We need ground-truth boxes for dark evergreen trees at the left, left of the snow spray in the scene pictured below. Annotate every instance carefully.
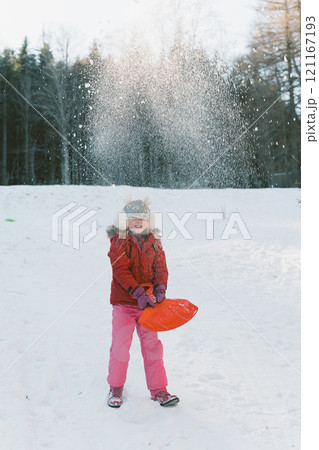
[0,38,96,185]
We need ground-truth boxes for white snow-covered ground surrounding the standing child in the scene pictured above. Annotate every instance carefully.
[0,186,300,450]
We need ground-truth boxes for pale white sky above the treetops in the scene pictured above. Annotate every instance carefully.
[0,0,258,59]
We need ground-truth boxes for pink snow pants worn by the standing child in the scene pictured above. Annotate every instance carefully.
[107,305,167,395]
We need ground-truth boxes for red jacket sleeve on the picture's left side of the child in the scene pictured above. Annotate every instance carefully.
[108,236,139,294]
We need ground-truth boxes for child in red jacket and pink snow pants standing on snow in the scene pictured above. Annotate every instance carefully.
[107,200,179,408]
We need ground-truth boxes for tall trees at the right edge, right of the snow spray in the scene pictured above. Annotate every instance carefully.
[233,0,301,187]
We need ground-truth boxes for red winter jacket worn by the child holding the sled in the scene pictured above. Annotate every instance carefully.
[108,231,168,305]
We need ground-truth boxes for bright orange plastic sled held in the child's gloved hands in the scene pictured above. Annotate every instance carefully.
[138,284,198,331]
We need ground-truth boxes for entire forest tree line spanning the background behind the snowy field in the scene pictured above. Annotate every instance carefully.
[0,0,300,187]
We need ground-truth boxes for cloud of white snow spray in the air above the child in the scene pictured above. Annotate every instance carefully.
[89,28,251,188]
